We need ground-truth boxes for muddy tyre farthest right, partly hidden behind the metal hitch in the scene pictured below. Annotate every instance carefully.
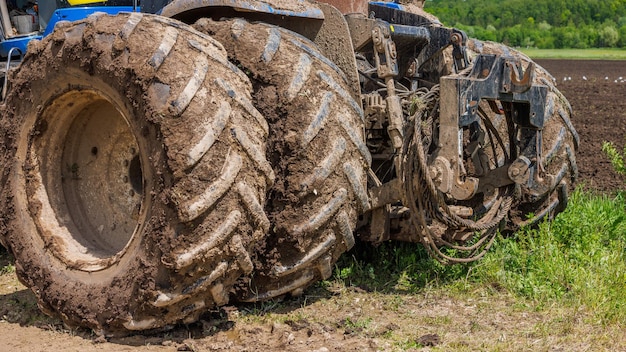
[468,40,579,230]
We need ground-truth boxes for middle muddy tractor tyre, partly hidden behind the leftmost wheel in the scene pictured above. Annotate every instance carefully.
[195,19,371,301]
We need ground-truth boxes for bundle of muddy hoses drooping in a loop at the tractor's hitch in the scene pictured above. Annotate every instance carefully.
[399,85,513,263]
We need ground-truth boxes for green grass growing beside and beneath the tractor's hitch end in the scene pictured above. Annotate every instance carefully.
[335,190,626,325]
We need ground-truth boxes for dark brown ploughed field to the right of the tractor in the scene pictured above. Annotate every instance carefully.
[537,60,626,193]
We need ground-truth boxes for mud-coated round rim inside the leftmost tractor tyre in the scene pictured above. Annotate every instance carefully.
[31,90,149,271]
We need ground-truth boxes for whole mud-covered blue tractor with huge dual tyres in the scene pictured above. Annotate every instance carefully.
[0,0,579,336]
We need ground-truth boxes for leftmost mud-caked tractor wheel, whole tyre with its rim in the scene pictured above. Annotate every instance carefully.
[0,13,274,335]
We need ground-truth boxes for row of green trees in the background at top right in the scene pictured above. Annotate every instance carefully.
[425,0,626,49]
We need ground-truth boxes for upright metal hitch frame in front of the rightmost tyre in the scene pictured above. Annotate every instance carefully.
[432,55,548,200]
